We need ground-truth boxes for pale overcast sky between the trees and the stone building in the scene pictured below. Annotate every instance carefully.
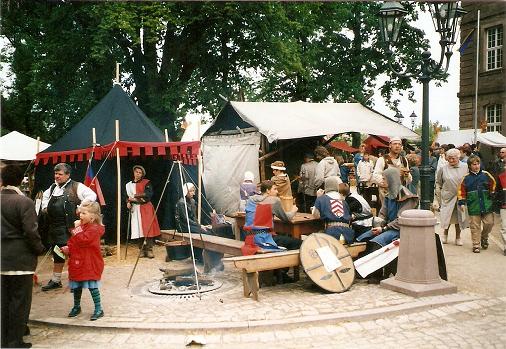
[373,12,460,130]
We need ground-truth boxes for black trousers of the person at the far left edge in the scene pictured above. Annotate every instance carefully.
[1,274,33,348]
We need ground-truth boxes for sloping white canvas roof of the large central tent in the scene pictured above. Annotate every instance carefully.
[206,101,418,142]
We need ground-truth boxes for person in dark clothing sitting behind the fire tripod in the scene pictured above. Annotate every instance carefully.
[175,183,224,272]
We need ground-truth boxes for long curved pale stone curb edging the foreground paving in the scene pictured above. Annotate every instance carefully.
[29,294,481,331]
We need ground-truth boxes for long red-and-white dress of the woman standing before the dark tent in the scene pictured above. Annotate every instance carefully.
[126,178,160,239]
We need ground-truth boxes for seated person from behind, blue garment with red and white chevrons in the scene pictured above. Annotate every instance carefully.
[313,176,355,244]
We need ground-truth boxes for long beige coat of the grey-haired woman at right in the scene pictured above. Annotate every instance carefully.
[436,161,469,230]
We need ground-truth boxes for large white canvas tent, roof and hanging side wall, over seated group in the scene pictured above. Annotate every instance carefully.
[202,102,418,214]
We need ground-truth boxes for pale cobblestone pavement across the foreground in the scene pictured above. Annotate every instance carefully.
[25,212,506,348]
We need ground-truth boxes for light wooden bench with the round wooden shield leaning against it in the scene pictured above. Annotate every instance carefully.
[223,242,366,301]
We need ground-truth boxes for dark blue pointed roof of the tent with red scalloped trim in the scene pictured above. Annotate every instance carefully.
[44,85,165,153]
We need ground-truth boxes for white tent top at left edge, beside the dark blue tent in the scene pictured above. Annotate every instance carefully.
[0,131,51,161]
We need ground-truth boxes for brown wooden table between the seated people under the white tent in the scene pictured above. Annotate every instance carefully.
[230,212,325,239]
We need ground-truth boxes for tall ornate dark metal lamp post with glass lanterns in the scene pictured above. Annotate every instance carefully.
[379,1,466,210]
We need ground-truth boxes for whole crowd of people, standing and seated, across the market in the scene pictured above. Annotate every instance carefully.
[0,137,506,347]
